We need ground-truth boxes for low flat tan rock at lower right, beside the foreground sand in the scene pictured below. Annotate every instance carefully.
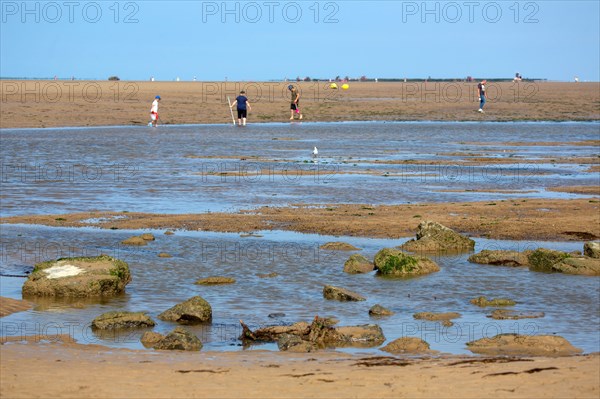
[467,334,581,356]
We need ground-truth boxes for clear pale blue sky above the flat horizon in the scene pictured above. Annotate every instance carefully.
[0,0,600,81]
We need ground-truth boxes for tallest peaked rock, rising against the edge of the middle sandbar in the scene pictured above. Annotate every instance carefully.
[401,220,475,252]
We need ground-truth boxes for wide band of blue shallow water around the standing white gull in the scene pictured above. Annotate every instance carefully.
[0,122,600,216]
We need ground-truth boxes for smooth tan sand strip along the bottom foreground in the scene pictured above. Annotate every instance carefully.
[0,337,600,398]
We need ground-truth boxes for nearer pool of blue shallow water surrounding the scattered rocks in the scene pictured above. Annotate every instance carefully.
[0,225,600,353]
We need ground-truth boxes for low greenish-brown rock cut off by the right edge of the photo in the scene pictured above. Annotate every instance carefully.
[528,248,600,276]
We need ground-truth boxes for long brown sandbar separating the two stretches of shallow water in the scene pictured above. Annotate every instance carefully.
[0,199,600,241]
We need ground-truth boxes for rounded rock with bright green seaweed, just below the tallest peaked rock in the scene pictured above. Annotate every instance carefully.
[374,248,440,277]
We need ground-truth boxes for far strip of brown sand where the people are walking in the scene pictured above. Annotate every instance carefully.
[0,80,600,128]
